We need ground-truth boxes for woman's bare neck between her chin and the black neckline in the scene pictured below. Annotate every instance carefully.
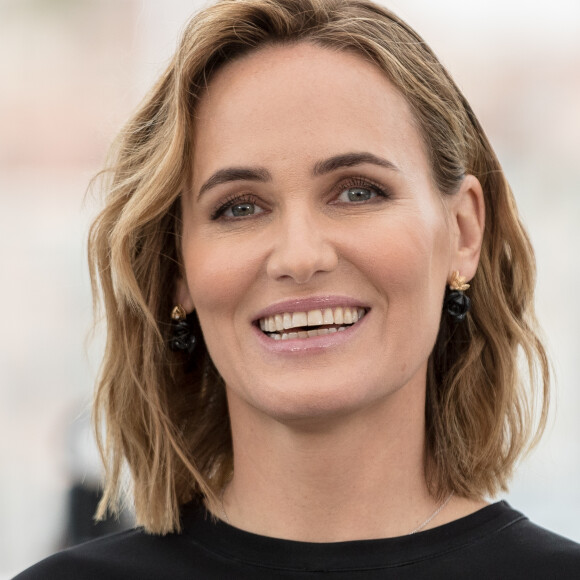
[217,372,450,542]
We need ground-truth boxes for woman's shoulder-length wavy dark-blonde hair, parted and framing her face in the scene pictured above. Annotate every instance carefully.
[89,0,549,534]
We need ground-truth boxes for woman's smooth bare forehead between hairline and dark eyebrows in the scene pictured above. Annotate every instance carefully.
[193,42,425,176]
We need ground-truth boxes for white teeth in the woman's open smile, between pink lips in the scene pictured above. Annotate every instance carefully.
[258,306,367,340]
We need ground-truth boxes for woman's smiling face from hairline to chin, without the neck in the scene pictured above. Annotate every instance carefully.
[178,43,457,420]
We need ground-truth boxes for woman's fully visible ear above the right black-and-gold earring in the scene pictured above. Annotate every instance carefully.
[450,175,485,280]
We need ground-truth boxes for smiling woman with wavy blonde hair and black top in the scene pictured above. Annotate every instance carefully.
[19,0,580,579]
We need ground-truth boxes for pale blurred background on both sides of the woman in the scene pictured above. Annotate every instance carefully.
[0,0,580,580]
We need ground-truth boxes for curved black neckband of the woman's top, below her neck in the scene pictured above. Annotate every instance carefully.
[182,501,526,572]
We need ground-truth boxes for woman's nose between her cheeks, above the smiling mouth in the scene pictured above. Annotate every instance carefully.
[267,211,338,284]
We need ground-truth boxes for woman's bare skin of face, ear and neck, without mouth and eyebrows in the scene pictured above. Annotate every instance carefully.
[176,43,484,541]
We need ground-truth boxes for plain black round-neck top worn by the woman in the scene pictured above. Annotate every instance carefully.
[16,502,580,580]
